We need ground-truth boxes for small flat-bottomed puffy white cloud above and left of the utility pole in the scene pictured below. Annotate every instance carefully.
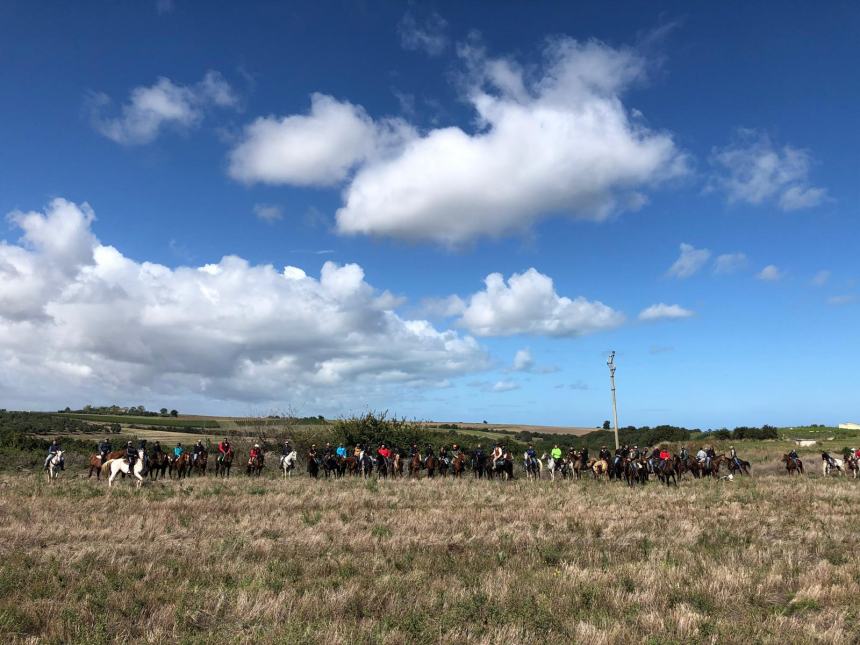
[458,268,624,336]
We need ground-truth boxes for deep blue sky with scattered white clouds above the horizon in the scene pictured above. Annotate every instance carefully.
[0,0,860,427]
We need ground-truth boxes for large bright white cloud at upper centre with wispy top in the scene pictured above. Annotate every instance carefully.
[230,38,687,245]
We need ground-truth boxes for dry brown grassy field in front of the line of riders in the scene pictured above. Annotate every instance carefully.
[0,442,860,643]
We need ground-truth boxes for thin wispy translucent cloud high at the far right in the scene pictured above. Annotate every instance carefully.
[710,130,828,211]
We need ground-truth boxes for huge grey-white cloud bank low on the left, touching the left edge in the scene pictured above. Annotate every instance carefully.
[0,199,488,405]
